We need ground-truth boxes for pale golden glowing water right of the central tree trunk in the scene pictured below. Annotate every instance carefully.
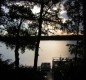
[38,41,75,64]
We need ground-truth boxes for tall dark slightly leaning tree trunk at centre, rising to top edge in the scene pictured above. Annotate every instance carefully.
[34,0,44,71]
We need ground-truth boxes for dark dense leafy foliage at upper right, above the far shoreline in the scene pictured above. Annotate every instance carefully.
[63,0,83,34]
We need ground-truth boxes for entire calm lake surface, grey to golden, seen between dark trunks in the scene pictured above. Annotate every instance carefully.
[0,41,76,66]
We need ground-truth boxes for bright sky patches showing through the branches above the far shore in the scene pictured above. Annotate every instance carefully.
[0,0,83,36]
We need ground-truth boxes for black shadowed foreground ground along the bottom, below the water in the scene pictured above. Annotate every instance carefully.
[0,64,86,80]
